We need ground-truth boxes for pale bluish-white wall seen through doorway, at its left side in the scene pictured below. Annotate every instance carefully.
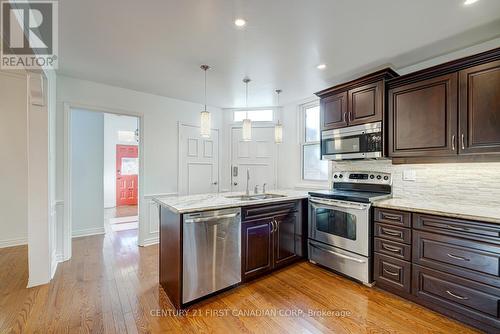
[70,109,104,236]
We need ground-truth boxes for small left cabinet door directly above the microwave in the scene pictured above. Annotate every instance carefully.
[320,92,347,130]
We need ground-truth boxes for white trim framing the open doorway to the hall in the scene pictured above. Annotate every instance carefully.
[62,102,147,261]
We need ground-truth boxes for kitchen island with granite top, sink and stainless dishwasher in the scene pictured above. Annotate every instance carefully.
[154,190,308,308]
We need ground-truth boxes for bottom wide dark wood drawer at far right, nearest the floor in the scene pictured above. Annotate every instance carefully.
[412,264,500,327]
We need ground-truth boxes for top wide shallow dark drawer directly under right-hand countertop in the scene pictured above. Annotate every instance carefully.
[413,213,500,243]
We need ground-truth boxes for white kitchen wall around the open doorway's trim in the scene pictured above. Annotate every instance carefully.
[57,76,224,244]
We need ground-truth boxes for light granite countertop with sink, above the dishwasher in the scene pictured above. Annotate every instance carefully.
[153,189,308,213]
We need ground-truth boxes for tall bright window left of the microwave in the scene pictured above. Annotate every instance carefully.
[301,102,328,181]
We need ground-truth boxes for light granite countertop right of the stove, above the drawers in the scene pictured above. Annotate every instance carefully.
[373,197,500,224]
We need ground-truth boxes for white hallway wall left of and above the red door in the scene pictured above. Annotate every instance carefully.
[104,113,139,208]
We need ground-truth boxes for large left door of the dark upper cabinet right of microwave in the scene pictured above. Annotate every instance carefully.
[388,73,458,157]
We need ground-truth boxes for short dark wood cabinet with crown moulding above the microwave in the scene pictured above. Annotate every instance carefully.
[316,68,398,130]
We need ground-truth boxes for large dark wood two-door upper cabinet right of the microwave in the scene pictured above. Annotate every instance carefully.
[387,48,500,163]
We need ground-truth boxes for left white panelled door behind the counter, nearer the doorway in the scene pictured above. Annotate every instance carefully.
[179,125,219,195]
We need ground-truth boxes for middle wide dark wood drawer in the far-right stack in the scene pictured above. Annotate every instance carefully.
[413,231,500,286]
